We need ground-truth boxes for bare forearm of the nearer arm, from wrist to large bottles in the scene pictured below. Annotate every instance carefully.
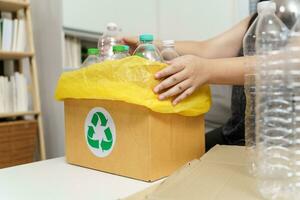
[206,57,250,85]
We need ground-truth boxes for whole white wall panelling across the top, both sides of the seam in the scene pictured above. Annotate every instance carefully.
[63,0,248,40]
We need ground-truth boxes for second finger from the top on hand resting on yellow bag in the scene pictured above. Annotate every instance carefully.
[154,70,187,93]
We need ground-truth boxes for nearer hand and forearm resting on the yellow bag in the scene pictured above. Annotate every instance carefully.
[154,55,248,105]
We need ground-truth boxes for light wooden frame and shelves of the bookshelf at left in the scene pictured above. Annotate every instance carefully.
[0,0,46,160]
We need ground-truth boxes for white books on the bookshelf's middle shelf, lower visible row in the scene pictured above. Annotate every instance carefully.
[0,72,28,113]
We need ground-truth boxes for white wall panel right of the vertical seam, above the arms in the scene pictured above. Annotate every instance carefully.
[159,0,234,40]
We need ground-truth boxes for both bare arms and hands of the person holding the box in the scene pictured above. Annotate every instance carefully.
[123,17,250,105]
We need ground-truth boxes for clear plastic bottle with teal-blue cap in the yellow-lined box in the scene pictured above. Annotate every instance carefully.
[133,34,162,62]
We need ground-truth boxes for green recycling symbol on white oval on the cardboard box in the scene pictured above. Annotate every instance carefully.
[84,107,116,158]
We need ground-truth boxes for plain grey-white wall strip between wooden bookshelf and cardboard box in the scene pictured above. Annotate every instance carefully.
[31,0,64,158]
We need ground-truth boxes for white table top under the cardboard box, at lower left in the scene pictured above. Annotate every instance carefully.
[0,157,162,200]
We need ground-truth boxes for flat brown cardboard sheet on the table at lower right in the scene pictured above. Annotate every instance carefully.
[126,146,262,200]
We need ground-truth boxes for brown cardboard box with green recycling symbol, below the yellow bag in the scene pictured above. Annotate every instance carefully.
[65,100,205,181]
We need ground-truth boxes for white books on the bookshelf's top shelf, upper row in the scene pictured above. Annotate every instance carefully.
[0,10,26,52]
